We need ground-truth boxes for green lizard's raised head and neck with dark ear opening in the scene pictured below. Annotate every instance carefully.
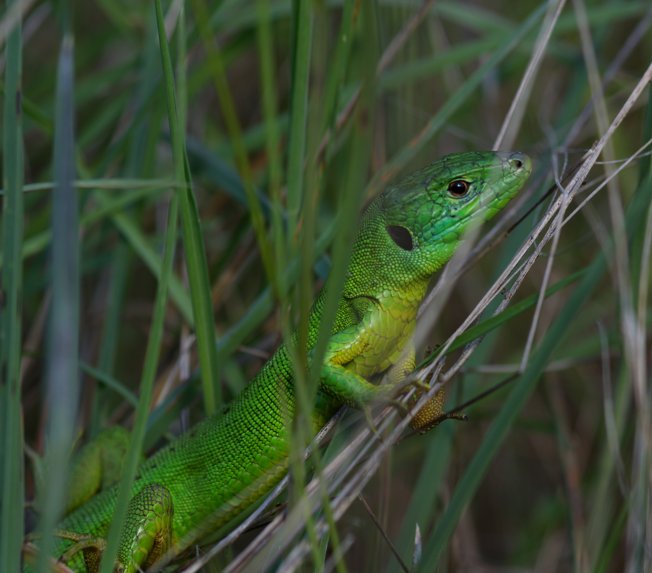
[345,152,532,298]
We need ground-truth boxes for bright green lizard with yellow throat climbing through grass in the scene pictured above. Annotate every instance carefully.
[27,152,531,572]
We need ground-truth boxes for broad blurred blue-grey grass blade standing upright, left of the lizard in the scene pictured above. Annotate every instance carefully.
[38,33,80,572]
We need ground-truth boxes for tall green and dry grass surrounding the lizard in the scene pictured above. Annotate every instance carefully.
[0,0,652,573]
